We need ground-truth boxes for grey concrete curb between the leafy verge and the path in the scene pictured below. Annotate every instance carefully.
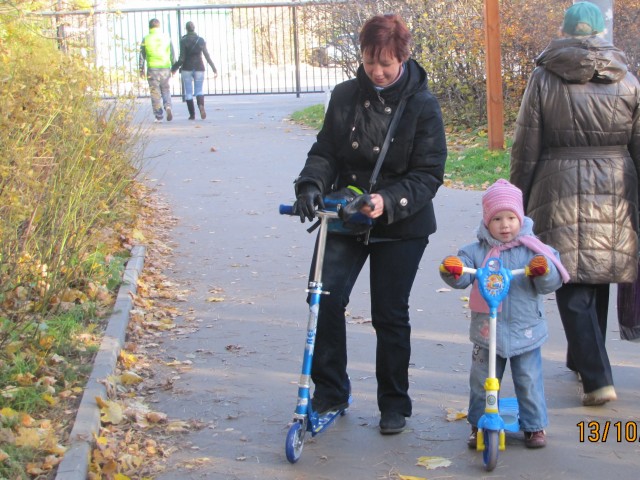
[56,246,146,480]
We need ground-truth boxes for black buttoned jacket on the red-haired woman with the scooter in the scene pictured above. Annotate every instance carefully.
[296,60,447,238]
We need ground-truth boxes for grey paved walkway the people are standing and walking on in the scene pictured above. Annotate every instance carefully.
[132,95,640,480]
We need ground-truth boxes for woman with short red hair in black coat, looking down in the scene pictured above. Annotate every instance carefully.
[295,15,447,434]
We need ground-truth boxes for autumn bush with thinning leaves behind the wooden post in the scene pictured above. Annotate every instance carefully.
[308,0,640,128]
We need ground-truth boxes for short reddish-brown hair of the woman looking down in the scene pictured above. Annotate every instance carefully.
[359,14,411,62]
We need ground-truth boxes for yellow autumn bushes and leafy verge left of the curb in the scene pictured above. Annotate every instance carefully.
[0,1,144,479]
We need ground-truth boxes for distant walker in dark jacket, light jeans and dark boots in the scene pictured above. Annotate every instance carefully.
[171,22,218,120]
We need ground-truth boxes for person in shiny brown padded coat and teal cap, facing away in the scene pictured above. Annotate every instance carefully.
[510,2,640,406]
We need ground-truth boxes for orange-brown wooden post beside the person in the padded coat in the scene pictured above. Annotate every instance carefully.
[484,0,504,150]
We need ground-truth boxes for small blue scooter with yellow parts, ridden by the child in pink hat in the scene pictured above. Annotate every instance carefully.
[462,257,525,471]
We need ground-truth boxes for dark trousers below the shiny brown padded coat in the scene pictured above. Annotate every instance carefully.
[556,283,613,393]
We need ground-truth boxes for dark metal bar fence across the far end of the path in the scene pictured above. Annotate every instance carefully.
[41,1,360,97]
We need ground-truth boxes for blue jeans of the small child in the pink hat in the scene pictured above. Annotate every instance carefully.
[467,345,548,432]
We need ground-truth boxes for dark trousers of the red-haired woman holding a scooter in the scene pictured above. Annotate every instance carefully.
[311,235,428,417]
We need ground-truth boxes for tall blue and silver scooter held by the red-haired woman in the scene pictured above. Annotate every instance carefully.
[280,199,370,463]
